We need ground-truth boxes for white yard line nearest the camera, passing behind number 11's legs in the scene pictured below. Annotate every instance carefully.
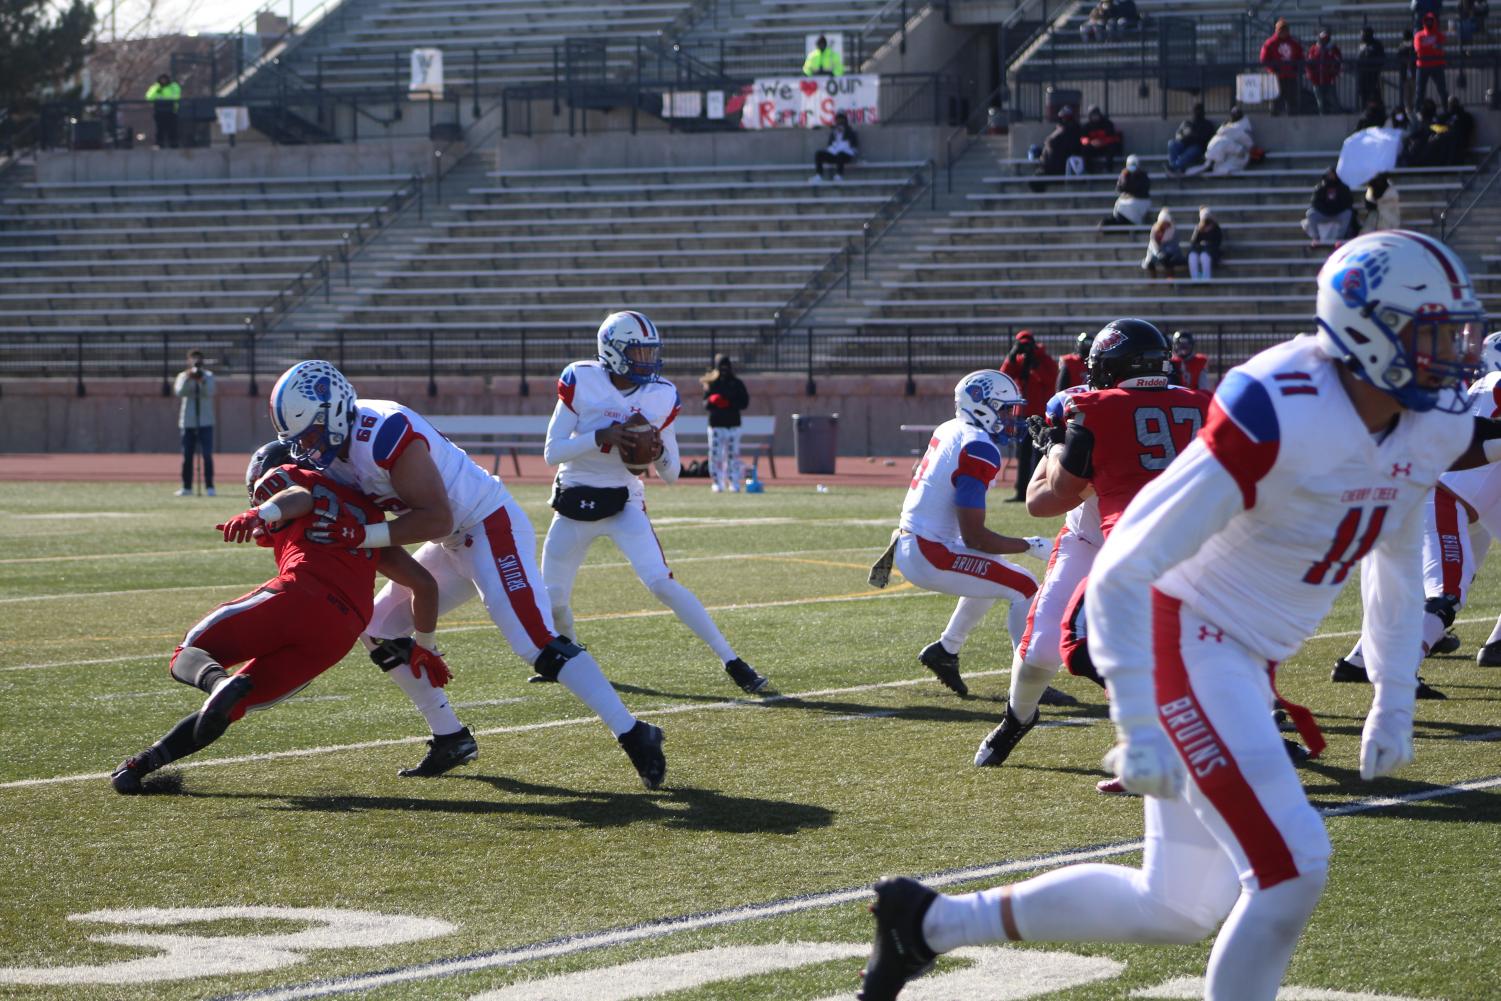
[216,776,1501,1001]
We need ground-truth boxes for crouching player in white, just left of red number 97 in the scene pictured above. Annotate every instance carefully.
[889,369,1049,695]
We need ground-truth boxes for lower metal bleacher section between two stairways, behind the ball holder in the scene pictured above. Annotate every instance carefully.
[311,162,923,368]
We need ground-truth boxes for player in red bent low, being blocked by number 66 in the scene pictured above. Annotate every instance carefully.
[110,441,449,794]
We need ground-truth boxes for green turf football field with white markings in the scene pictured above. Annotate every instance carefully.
[0,483,1501,1001]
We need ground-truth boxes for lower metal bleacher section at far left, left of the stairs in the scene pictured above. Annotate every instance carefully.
[0,174,414,374]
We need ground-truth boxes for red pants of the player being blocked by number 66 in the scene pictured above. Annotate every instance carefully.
[173,576,365,720]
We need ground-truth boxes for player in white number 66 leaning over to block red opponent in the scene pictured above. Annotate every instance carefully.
[270,362,666,789]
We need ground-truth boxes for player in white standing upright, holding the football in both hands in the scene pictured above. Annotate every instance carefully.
[542,311,767,695]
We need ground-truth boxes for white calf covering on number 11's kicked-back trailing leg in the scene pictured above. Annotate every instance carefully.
[1001,863,1224,948]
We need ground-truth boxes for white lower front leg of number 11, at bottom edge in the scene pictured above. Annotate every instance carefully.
[1205,869,1328,1001]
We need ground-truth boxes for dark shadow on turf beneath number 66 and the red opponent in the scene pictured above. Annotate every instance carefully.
[188,774,835,834]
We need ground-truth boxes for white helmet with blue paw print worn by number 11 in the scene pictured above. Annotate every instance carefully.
[1318,230,1486,413]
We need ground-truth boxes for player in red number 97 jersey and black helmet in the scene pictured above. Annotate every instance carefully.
[974,320,1210,767]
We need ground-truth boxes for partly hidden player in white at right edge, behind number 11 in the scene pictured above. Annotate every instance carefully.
[1331,333,1501,681]
